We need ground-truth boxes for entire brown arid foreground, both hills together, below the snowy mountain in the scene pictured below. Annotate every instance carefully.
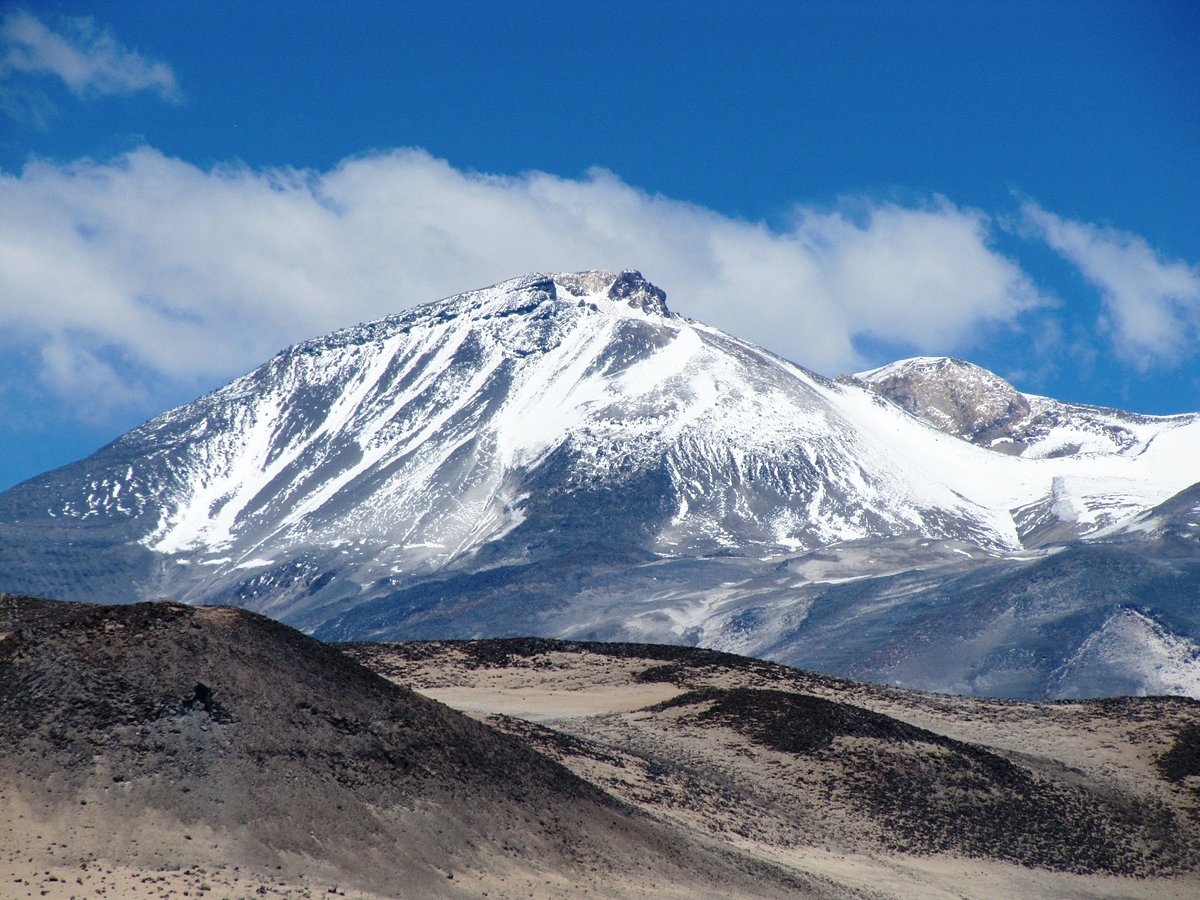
[0,595,1200,898]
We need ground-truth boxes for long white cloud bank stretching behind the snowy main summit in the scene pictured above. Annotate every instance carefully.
[0,148,1040,417]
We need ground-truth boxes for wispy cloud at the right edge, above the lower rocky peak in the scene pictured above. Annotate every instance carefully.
[1021,202,1200,371]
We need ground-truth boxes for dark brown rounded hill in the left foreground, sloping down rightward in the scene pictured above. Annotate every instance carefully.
[0,595,830,898]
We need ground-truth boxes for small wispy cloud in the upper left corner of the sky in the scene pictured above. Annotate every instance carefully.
[0,10,180,101]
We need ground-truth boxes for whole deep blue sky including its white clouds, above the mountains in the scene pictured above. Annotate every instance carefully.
[0,0,1200,487]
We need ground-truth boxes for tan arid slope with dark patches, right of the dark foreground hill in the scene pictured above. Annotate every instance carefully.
[347,638,1200,898]
